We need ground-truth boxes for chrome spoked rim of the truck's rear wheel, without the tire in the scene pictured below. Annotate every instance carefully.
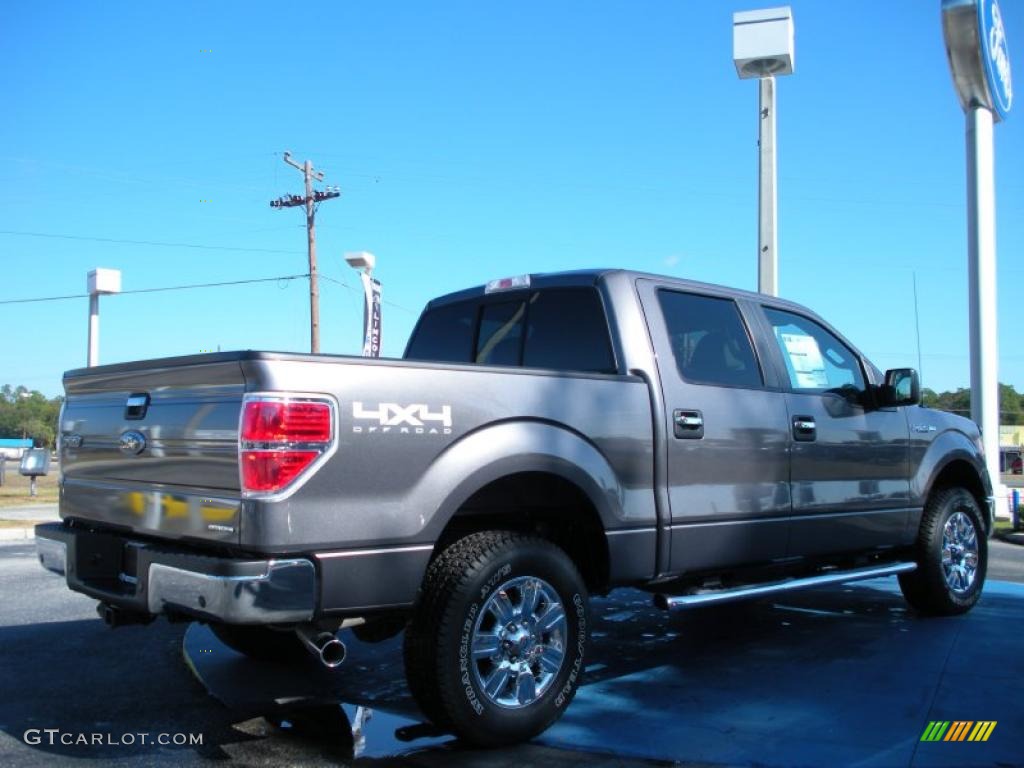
[471,577,566,709]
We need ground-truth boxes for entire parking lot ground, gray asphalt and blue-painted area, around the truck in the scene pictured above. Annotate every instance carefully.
[0,541,1024,766]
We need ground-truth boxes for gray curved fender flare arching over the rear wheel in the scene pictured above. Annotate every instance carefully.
[413,421,630,541]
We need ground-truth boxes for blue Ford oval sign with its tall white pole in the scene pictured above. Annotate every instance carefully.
[942,0,1014,512]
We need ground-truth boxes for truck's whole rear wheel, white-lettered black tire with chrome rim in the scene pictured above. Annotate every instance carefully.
[404,530,590,746]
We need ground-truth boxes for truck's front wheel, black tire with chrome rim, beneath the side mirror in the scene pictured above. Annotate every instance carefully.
[899,487,988,616]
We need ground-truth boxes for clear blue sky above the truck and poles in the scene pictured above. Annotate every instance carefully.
[0,0,1024,394]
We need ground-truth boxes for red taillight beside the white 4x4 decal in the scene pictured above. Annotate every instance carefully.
[239,395,334,496]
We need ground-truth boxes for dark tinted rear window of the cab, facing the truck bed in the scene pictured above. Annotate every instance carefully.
[406,288,615,374]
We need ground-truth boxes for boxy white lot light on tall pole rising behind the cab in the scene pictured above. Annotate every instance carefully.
[732,7,794,296]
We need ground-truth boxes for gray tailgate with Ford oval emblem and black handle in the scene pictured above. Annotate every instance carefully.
[60,353,245,543]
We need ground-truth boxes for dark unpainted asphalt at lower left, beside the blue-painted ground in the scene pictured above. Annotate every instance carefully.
[0,541,699,768]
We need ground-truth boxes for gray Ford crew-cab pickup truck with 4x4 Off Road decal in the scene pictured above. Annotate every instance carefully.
[36,269,992,744]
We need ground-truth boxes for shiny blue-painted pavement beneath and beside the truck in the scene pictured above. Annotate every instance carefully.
[183,580,1024,766]
